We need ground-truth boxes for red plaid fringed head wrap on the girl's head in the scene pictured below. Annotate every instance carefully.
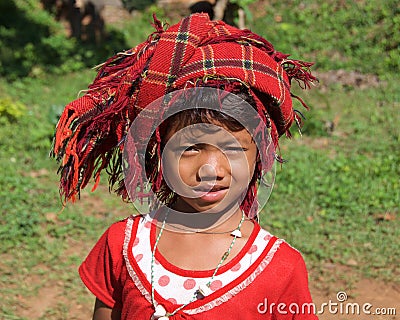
[52,14,316,210]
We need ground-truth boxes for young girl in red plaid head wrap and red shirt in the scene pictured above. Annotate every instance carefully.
[53,14,316,320]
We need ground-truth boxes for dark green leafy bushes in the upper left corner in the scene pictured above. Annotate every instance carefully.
[0,0,128,81]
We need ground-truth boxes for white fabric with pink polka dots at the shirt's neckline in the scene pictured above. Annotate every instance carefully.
[132,216,272,304]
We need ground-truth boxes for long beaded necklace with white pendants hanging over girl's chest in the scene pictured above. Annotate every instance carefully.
[151,211,245,320]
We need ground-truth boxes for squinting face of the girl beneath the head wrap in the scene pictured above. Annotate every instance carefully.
[162,123,257,212]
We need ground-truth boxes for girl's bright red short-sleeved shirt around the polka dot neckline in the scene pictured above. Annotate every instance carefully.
[79,216,317,320]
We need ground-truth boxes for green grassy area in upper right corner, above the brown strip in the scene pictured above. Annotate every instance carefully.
[253,0,400,76]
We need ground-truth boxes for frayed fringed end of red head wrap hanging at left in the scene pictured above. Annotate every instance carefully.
[50,16,164,201]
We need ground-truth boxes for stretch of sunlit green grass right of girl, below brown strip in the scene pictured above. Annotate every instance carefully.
[262,78,400,281]
